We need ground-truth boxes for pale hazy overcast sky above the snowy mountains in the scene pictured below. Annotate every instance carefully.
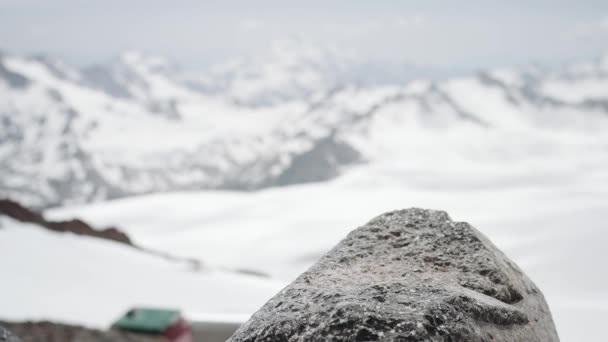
[0,0,608,69]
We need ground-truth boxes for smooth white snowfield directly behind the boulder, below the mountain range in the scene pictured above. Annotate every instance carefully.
[47,167,608,342]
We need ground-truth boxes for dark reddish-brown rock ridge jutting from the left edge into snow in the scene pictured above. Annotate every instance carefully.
[0,199,133,245]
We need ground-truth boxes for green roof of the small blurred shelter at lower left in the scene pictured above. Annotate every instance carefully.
[112,308,181,334]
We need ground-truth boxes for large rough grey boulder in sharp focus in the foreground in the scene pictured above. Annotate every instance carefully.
[228,209,559,342]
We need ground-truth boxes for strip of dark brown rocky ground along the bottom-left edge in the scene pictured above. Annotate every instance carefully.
[0,321,165,342]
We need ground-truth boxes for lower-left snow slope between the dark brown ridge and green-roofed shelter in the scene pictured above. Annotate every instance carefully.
[0,216,284,328]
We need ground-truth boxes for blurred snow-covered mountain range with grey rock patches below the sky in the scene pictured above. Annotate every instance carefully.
[0,42,608,206]
